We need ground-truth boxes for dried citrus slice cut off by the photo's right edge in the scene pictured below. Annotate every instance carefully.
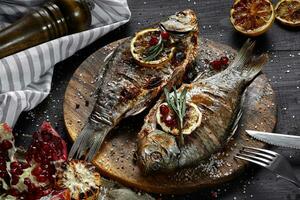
[275,0,300,27]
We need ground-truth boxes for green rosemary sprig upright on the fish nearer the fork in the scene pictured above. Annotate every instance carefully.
[164,87,187,146]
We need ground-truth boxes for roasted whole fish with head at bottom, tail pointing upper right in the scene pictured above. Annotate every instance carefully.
[138,41,268,174]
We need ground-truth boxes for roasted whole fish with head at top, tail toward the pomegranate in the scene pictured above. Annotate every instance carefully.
[69,10,199,160]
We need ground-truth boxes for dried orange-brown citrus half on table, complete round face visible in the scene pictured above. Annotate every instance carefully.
[230,0,275,37]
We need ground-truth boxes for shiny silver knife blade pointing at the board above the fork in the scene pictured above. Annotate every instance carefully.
[246,130,300,149]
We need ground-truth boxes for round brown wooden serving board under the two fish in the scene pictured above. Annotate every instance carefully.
[64,39,276,194]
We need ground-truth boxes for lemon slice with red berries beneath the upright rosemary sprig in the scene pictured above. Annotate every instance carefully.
[156,102,202,136]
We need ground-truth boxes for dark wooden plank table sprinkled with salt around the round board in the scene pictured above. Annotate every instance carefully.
[15,0,300,200]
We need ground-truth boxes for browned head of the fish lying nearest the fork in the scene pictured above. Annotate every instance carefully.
[138,129,180,174]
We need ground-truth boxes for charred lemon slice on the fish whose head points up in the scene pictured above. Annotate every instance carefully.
[130,28,175,67]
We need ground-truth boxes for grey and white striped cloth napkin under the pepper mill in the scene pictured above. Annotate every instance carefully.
[0,0,131,126]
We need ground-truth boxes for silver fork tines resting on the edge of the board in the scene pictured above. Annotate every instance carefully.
[235,146,278,167]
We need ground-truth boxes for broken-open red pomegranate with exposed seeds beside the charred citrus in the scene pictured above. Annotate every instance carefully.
[0,122,67,200]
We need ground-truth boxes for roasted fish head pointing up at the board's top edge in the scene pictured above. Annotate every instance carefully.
[160,9,198,33]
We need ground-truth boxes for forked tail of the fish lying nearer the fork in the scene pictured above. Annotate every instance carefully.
[228,39,268,82]
